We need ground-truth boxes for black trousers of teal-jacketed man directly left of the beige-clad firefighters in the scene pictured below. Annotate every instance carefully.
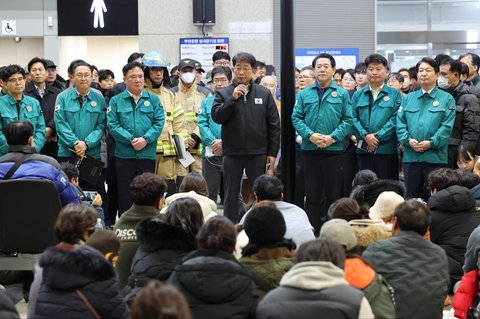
[115,157,155,217]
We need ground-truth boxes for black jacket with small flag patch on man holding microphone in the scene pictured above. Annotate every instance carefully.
[212,81,280,156]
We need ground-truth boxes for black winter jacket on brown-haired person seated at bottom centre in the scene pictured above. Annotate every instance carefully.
[169,249,258,319]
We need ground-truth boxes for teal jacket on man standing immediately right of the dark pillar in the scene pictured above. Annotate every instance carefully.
[292,81,352,152]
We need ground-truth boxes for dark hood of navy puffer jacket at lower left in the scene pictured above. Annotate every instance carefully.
[39,246,115,290]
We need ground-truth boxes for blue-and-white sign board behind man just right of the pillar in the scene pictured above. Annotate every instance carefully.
[295,48,358,69]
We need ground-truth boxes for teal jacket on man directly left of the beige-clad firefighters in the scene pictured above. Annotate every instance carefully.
[107,90,165,160]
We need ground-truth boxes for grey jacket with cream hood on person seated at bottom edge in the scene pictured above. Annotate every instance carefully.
[257,261,374,319]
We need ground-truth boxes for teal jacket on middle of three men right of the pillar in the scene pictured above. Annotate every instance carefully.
[352,84,402,154]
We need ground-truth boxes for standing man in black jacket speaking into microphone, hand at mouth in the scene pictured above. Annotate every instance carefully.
[212,52,280,223]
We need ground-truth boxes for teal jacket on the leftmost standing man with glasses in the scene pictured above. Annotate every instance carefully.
[0,94,47,156]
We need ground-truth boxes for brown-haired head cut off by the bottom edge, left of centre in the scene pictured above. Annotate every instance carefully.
[129,279,192,319]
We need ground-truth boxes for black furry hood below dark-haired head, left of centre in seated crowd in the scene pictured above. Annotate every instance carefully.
[136,218,195,252]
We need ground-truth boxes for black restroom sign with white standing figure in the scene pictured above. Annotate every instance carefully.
[57,0,138,36]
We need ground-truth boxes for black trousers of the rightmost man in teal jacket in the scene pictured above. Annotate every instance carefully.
[403,162,446,201]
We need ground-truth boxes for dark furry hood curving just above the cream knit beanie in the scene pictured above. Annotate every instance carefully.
[350,179,406,207]
